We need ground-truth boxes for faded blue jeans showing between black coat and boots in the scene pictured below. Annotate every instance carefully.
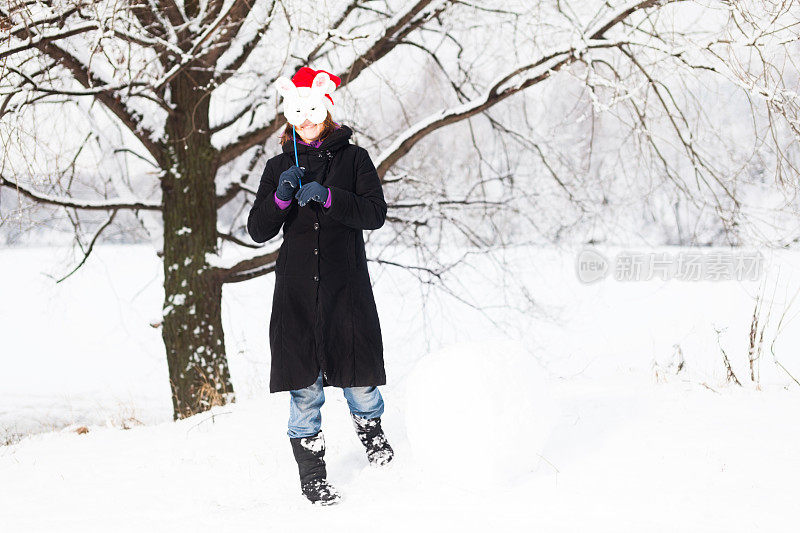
[287,371,383,438]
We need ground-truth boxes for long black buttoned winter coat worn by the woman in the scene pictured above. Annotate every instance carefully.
[247,125,386,392]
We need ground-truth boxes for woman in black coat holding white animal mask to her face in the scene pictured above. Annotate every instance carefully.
[247,67,393,505]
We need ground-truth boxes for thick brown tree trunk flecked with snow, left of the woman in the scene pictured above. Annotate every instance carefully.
[161,68,234,420]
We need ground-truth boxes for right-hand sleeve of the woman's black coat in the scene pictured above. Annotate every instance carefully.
[323,148,386,229]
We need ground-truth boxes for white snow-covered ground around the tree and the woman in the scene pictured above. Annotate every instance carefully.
[0,246,800,532]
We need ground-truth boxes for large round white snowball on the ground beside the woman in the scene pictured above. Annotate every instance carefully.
[406,339,557,488]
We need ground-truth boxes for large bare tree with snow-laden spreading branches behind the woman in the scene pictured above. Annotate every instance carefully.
[0,0,798,418]
